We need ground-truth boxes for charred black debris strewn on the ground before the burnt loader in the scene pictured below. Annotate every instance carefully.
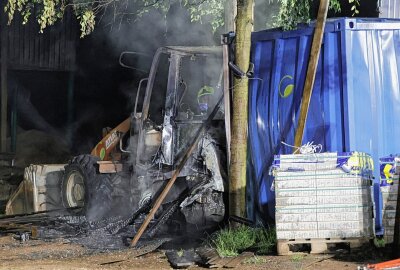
[0,211,170,251]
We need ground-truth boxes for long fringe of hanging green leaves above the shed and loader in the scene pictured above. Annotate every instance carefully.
[5,0,226,37]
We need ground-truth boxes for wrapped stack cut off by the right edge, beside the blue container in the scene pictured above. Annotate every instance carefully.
[379,155,400,244]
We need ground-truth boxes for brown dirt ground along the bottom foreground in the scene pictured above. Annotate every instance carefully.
[0,236,390,270]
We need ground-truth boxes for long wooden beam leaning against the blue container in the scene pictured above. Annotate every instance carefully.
[294,0,329,151]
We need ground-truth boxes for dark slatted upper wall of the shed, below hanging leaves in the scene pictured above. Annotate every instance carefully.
[7,12,78,71]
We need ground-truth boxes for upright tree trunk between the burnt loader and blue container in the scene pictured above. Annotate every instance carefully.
[228,0,254,217]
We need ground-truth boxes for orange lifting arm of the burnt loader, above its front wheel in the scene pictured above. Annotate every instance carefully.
[91,117,131,160]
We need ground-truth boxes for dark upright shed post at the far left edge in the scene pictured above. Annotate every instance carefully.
[0,8,8,152]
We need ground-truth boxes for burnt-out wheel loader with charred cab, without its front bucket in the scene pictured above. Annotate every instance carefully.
[60,47,230,234]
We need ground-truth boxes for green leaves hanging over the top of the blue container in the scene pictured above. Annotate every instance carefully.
[276,0,360,30]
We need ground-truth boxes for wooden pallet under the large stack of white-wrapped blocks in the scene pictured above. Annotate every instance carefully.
[277,238,370,255]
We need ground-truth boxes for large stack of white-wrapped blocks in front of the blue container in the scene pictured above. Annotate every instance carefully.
[271,152,374,240]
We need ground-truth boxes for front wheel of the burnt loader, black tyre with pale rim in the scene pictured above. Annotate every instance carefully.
[61,155,113,221]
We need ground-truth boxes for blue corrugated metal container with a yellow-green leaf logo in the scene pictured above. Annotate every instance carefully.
[248,18,400,234]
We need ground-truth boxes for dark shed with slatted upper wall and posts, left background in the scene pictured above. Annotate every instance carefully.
[0,7,79,152]
